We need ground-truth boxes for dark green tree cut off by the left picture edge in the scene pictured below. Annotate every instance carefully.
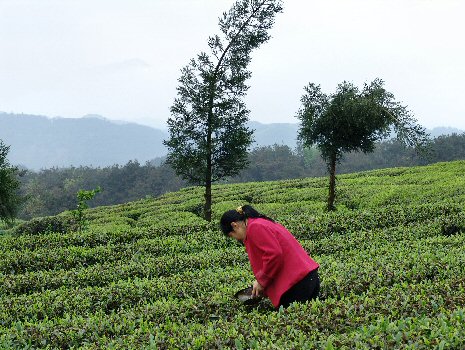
[0,140,22,224]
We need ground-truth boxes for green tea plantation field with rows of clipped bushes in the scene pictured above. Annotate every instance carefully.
[0,161,465,349]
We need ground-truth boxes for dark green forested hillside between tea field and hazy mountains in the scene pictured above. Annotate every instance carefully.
[16,134,465,219]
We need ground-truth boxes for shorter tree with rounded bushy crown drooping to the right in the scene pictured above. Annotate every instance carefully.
[297,79,429,210]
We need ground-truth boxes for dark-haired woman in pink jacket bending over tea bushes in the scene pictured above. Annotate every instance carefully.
[220,205,320,308]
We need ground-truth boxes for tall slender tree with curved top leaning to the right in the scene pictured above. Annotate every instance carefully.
[164,0,282,221]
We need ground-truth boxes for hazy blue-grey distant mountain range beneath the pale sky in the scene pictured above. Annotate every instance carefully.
[0,112,463,170]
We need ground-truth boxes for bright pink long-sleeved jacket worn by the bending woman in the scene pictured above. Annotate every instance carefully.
[244,218,319,307]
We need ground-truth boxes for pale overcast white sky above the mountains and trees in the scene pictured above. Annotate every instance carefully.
[0,0,465,129]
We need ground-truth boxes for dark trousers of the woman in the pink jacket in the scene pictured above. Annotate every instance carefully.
[279,269,320,308]
